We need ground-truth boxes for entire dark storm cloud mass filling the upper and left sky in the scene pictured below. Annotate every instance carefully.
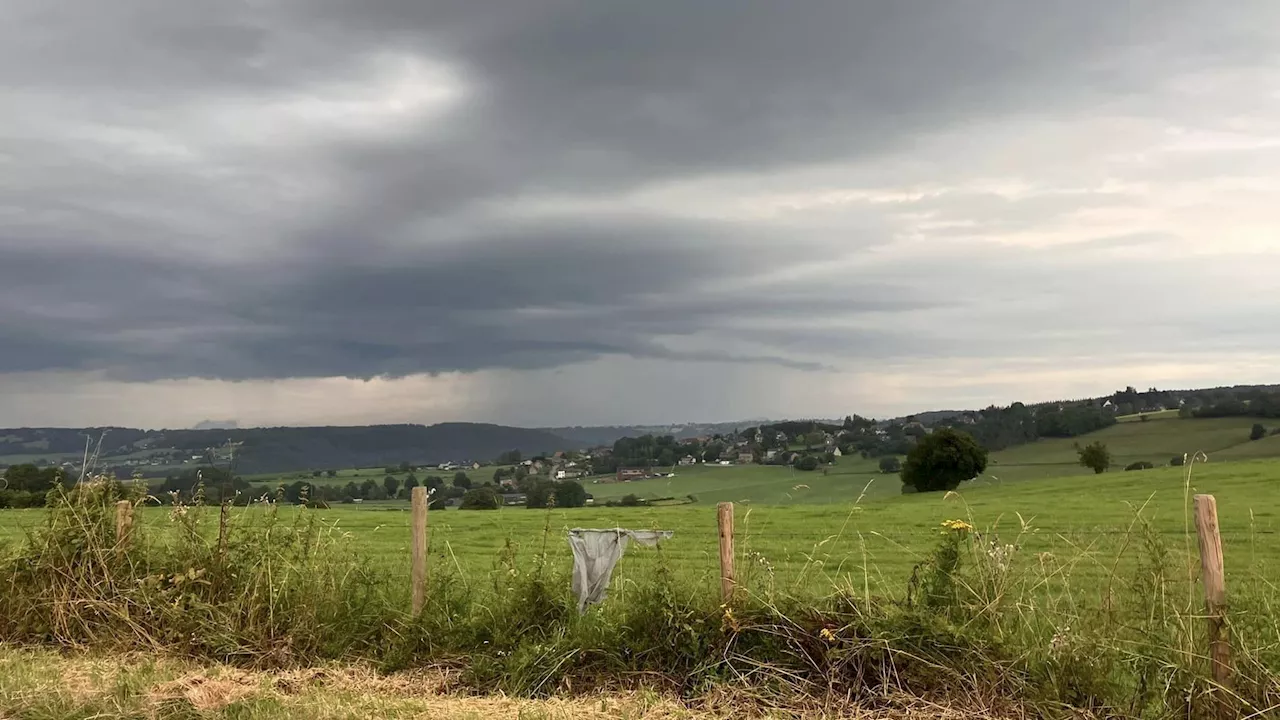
[0,0,1274,379]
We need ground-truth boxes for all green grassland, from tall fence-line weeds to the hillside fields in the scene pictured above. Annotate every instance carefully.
[0,418,1280,719]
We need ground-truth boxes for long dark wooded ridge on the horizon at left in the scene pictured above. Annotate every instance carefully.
[0,423,576,475]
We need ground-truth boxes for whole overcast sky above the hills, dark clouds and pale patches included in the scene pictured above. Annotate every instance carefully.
[0,0,1280,428]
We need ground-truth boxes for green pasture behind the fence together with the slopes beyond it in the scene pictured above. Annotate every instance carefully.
[0,418,1280,592]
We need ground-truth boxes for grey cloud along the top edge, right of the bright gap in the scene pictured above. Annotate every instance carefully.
[294,0,1178,222]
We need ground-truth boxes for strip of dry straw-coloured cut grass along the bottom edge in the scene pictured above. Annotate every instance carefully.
[0,647,1032,720]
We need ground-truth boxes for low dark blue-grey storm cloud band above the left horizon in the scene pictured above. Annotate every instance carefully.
[0,217,922,379]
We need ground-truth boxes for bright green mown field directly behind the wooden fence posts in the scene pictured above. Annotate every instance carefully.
[0,456,1280,596]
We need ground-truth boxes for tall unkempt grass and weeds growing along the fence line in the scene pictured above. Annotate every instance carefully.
[0,468,1280,717]
